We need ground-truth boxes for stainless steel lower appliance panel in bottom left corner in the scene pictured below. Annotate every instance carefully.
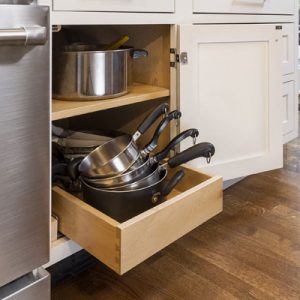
[0,268,51,300]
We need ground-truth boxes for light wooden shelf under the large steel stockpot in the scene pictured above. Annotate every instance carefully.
[52,83,170,121]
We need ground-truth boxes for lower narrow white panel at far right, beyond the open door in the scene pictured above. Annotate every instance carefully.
[282,81,298,143]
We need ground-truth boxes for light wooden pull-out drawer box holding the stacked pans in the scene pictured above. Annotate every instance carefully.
[52,166,223,275]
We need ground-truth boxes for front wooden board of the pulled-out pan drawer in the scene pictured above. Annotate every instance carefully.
[119,177,223,274]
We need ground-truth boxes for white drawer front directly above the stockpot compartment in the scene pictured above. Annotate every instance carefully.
[53,0,175,12]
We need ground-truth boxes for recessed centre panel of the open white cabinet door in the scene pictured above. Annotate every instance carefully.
[194,42,269,164]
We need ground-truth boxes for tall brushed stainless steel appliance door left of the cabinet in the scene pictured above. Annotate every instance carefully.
[0,5,50,286]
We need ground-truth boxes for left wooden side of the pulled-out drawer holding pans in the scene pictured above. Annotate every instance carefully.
[52,187,120,273]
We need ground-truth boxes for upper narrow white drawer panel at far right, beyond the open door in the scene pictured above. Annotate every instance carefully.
[281,24,295,75]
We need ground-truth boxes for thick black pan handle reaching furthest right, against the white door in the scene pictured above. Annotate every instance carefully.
[168,142,215,168]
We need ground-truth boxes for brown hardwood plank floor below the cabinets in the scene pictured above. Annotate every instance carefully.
[52,120,300,300]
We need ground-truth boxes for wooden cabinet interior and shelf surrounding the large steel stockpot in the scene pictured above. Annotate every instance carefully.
[52,25,170,150]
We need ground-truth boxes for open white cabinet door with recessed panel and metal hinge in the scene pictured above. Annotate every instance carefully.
[178,24,283,180]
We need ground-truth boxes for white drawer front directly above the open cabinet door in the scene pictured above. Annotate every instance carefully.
[193,0,295,14]
